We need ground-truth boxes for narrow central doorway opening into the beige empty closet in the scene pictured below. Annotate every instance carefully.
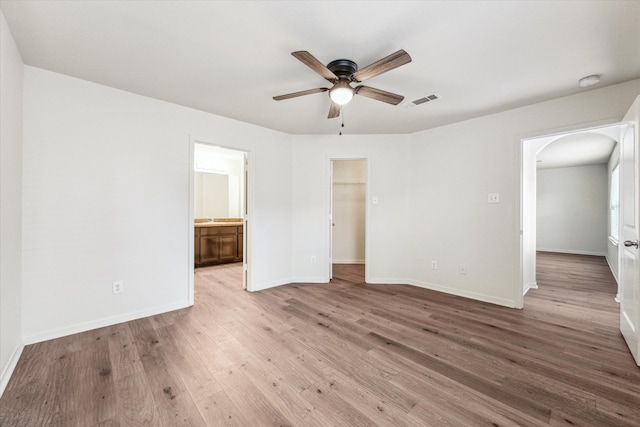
[330,159,368,282]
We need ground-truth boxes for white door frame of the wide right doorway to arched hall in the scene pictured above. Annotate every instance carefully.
[513,119,628,309]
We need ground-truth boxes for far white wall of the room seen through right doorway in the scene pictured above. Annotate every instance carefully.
[537,164,608,256]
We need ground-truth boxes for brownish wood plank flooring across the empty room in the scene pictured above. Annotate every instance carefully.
[0,253,640,427]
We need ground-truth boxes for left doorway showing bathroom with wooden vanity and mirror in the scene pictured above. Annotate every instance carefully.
[188,138,251,304]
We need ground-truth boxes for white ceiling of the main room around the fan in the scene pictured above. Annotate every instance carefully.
[0,0,640,138]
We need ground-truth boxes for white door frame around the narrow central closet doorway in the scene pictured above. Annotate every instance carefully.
[324,154,371,283]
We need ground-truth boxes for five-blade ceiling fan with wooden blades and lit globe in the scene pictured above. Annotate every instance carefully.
[273,49,411,119]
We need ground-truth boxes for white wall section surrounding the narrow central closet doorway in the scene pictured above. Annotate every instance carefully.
[290,135,409,283]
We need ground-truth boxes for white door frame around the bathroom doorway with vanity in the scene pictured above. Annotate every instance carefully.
[187,136,253,305]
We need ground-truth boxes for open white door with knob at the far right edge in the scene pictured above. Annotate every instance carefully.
[619,96,640,366]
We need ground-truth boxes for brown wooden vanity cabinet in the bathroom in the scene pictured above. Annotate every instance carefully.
[194,225,244,267]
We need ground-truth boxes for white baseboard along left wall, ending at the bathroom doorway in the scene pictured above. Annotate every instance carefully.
[23,301,190,345]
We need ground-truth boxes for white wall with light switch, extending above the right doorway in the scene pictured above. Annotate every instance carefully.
[404,80,640,306]
